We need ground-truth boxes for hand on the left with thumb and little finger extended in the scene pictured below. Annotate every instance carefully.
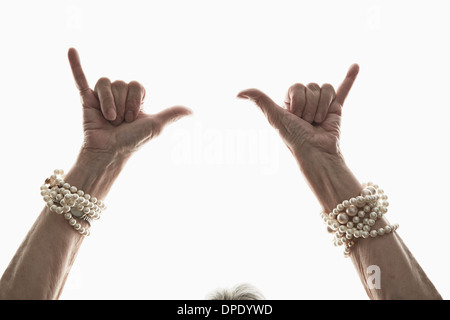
[68,48,192,157]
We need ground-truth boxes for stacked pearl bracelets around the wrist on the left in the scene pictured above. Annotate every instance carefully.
[41,170,106,236]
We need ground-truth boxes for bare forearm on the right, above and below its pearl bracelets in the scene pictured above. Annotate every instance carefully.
[297,151,441,299]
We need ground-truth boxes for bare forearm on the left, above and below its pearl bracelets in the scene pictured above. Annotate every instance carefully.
[0,151,126,299]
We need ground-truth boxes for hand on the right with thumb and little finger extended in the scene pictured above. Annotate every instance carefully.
[238,64,359,158]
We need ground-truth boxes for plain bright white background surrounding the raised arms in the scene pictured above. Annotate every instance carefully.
[0,0,450,299]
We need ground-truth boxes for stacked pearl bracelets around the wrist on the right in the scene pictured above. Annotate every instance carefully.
[321,182,399,257]
